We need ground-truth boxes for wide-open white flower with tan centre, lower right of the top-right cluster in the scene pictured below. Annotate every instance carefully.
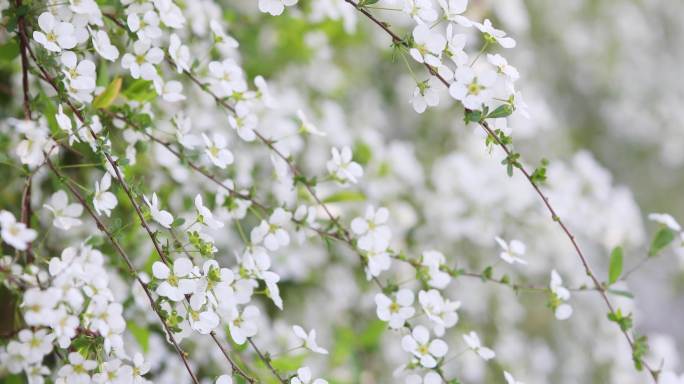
[449,66,496,109]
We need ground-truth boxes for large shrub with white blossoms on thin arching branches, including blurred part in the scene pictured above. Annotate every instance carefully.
[0,0,684,384]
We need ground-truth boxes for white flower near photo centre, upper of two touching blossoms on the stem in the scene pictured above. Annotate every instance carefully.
[351,205,392,251]
